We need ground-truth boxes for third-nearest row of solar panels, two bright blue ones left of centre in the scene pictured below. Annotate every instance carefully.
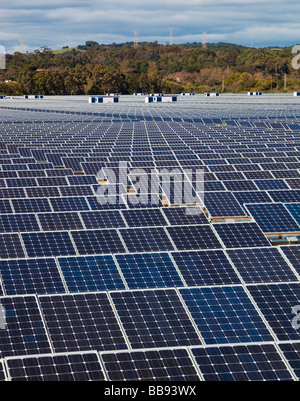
[0,246,300,296]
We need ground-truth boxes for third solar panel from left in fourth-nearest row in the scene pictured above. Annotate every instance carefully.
[71,229,125,256]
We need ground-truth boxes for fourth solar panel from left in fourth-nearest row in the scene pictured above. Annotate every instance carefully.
[120,227,174,252]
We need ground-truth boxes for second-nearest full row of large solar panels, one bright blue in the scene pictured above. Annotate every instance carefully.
[0,282,300,358]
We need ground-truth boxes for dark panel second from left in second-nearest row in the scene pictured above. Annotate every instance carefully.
[39,293,127,352]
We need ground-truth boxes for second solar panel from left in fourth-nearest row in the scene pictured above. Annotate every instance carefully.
[22,232,76,258]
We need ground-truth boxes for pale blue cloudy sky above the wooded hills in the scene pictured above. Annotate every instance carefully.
[0,0,300,53]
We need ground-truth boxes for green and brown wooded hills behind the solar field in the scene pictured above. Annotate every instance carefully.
[0,41,300,95]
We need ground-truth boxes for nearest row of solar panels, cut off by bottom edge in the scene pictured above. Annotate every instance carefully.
[0,342,300,382]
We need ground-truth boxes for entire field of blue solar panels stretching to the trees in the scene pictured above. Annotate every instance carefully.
[0,95,300,381]
